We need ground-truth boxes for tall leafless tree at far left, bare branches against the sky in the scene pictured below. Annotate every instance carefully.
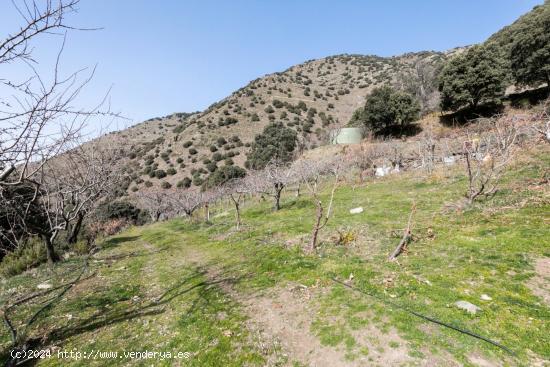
[0,0,118,261]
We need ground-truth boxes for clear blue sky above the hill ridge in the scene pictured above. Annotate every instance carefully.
[0,0,543,131]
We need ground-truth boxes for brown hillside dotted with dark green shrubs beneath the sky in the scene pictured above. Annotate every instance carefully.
[105,49,460,191]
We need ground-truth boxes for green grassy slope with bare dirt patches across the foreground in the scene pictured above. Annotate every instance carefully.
[1,150,550,366]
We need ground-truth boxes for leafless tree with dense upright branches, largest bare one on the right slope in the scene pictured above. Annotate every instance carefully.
[463,117,517,204]
